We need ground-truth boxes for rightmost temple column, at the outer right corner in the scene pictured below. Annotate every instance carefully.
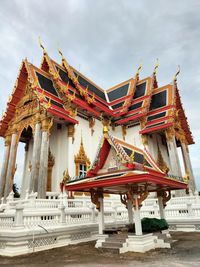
[181,142,196,193]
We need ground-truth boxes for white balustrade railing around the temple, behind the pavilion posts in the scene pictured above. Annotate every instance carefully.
[0,195,200,229]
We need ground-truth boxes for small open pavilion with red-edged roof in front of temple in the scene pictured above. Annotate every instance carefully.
[65,126,188,252]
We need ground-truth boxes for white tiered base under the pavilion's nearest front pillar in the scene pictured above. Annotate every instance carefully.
[120,234,156,253]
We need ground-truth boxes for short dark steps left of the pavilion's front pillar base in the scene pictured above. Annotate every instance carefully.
[101,233,128,254]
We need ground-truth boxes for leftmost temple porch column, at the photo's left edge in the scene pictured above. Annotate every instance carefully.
[0,136,10,200]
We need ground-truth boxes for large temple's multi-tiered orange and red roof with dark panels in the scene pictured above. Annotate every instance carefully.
[0,51,194,147]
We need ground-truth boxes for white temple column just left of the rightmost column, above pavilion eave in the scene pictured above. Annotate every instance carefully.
[167,136,182,177]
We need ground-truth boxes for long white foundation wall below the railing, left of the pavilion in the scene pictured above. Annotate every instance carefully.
[0,224,98,257]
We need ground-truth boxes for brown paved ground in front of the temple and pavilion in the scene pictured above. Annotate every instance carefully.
[0,232,200,267]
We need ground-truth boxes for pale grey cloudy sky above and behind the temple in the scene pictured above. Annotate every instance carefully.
[0,0,200,191]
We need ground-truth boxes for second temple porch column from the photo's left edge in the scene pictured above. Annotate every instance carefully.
[4,133,17,198]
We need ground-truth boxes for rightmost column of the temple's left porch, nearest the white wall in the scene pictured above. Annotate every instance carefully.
[37,131,49,198]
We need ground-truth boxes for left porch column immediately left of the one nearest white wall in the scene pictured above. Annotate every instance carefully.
[29,122,41,193]
